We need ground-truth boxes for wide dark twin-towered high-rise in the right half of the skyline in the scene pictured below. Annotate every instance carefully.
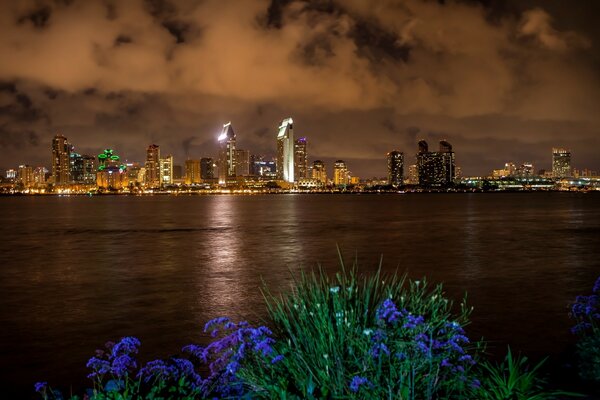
[417,140,456,187]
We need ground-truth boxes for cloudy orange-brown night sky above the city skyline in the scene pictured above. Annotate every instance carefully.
[0,0,600,177]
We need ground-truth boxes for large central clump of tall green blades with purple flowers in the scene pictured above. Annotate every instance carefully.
[238,258,478,399]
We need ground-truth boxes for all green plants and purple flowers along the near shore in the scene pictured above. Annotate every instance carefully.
[35,263,600,400]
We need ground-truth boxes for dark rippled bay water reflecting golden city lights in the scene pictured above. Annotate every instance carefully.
[0,193,600,397]
